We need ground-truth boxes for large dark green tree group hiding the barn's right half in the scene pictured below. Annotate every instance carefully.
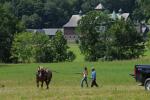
[78,11,145,61]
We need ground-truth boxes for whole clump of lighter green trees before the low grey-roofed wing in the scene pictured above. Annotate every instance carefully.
[11,32,75,63]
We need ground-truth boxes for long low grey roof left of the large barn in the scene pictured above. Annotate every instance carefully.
[27,28,63,36]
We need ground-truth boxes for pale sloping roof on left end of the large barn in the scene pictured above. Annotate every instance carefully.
[63,15,82,27]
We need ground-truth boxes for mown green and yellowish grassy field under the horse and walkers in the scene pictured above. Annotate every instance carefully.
[0,47,150,100]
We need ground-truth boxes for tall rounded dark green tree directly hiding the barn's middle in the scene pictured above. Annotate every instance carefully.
[78,11,110,61]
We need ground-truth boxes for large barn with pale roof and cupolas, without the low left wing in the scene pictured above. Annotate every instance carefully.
[63,3,129,42]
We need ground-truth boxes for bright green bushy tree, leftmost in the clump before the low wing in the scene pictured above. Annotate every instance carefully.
[11,32,36,63]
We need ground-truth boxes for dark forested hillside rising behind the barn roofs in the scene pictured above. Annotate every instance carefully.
[0,0,143,28]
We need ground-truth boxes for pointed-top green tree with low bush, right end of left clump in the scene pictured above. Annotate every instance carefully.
[52,31,76,62]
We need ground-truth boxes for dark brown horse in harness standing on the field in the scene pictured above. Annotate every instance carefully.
[36,67,52,89]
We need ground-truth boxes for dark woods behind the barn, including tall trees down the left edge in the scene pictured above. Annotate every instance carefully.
[0,0,150,62]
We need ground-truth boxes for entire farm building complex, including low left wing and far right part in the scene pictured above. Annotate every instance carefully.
[27,3,150,42]
